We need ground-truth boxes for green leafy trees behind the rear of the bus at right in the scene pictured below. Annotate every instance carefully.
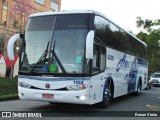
[136,17,160,74]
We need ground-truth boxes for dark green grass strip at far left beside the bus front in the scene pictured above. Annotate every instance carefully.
[0,78,18,97]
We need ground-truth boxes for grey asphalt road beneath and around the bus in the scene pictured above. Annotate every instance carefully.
[0,87,160,120]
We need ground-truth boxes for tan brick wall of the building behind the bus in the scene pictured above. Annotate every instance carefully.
[0,0,61,55]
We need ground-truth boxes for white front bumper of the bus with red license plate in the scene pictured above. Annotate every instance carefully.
[18,87,89,104]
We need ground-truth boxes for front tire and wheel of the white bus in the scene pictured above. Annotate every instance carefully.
[99,81,112,108]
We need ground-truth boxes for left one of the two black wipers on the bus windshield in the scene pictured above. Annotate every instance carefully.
[30,41,50,73]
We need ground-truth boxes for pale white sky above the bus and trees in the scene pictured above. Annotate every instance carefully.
[61,0,160,34]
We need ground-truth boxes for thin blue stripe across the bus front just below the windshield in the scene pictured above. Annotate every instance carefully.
[18,75,90,81]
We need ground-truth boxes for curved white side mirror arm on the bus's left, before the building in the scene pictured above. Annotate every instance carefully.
[7,34,20,60]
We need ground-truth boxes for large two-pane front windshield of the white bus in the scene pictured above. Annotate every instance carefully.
[20,14,89,74]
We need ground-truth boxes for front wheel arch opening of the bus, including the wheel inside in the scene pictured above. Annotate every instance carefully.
[99,77,114,108]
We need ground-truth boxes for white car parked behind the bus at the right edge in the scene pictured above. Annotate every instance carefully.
[149,72,160,86]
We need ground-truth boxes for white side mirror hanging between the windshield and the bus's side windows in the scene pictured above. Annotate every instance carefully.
[86,30,95,59]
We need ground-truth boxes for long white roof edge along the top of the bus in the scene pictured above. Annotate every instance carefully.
[29,10,147,47]
